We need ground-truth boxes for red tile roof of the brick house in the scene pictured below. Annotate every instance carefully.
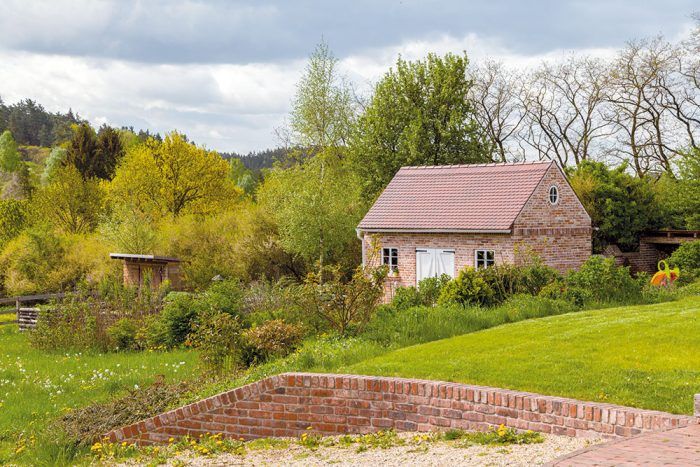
[358,162,552,231]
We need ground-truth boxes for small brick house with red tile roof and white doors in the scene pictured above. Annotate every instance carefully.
[357,162,592,300]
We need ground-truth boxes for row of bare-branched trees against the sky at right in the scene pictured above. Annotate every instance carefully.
[470,27,700,177]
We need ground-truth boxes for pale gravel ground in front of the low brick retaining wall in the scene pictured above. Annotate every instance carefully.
[161,433,604,466]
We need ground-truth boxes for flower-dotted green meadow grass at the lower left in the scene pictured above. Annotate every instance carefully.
[0,325,199,463]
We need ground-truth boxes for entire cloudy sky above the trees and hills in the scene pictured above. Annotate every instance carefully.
[0,0,700,152]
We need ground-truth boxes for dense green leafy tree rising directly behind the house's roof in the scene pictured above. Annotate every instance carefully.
[352,54,491,200]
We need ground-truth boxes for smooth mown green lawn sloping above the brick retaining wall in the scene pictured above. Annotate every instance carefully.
[344,296,700,414]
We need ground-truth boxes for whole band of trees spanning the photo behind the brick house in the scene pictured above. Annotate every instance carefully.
[0,18,700,293]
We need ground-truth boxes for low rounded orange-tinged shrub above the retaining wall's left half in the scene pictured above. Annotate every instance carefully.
[244,319,304,363]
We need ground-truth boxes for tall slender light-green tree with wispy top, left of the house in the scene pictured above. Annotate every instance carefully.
[259,42,359,270]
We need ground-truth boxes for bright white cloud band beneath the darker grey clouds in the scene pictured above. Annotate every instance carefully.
[0,34,636,152]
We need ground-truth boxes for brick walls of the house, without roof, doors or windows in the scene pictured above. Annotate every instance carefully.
[362,165,592,301]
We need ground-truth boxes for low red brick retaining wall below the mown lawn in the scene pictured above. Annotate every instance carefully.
[106,373,697,444]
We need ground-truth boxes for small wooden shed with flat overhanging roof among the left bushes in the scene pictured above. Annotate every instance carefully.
[109,253,182,290]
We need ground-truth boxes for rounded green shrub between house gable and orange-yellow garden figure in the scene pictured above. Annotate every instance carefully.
[564,255,643,303]
